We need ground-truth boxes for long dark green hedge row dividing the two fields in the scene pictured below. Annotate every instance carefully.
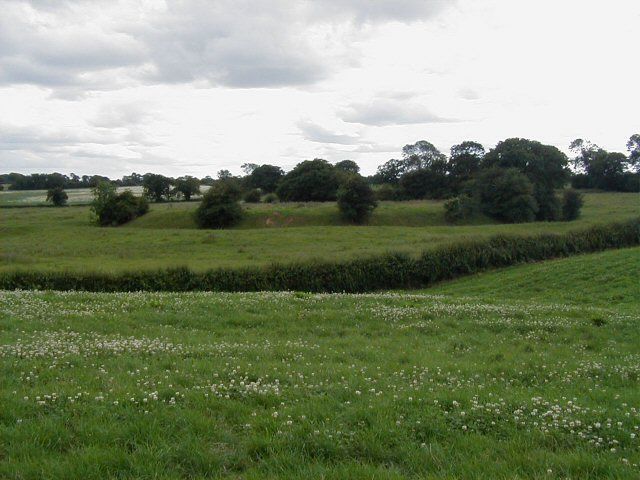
[0,219,640,292]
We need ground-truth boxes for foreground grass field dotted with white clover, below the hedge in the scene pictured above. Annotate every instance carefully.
[0,248,640,479]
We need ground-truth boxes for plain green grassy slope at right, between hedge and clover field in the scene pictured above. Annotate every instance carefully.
[425,248,640,308]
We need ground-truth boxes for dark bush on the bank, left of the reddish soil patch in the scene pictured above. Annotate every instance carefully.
[195,180,244,228]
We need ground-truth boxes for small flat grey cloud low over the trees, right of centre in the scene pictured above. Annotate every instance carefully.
[341,98,453,127]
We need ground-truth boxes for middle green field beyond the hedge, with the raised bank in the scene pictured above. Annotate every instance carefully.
[0,193,640,271]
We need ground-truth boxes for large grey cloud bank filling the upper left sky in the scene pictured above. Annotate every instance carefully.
[0,0,450,94]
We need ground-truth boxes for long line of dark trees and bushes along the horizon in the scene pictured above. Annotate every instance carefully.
[3,134,640,228]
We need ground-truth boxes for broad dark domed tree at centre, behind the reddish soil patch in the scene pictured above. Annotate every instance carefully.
[277,158,338,202]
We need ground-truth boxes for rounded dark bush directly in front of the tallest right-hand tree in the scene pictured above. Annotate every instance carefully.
[472,167,538,223]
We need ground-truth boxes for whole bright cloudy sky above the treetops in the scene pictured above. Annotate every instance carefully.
[0,0,640,177]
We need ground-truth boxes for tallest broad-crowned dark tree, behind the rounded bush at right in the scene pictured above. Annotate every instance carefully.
[481,138,569,220]
